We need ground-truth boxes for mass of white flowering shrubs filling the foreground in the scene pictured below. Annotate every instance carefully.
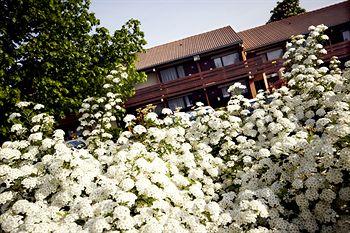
[0,25,350,233]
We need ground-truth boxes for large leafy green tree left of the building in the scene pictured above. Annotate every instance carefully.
[0,0,145,141]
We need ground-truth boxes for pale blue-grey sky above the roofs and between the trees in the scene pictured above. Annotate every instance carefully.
[90,0,344,48]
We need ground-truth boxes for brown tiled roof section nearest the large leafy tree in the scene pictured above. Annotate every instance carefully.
[136,26,242,70]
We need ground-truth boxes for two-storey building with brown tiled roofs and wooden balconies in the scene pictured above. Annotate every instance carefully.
[126,1,350,114]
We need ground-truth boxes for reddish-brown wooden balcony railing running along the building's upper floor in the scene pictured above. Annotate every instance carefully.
[126,41,350,107]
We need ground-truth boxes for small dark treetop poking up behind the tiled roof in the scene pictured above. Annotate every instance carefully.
[267,0,305,23]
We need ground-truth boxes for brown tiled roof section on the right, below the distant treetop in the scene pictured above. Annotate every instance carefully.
[238,1,350,51]
